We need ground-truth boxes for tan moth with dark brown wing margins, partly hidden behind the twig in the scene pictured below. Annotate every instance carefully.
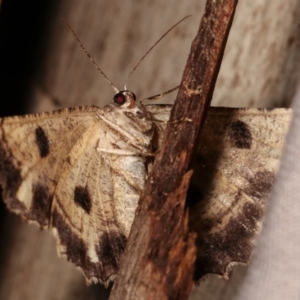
[0,18,291,285]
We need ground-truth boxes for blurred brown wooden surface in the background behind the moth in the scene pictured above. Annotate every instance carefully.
[0,0,300,300]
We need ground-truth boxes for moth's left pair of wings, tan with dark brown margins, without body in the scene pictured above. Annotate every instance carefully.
[0,107,126,283]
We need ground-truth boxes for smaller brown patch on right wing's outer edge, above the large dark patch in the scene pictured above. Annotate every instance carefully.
[244,171,275,201]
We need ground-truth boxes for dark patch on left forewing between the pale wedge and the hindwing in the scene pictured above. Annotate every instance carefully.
[28,183,52,227]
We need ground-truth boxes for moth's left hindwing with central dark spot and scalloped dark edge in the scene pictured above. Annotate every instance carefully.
[52,114,127,284]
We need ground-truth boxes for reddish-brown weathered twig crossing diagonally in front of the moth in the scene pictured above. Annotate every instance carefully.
[110,0,237,300]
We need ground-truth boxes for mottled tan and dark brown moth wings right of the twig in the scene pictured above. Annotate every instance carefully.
[149,107,292,279]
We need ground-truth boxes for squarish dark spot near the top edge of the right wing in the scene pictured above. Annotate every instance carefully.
[229,120,252,149]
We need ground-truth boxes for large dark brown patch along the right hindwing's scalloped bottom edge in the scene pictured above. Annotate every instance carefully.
[195,202,263,280]
